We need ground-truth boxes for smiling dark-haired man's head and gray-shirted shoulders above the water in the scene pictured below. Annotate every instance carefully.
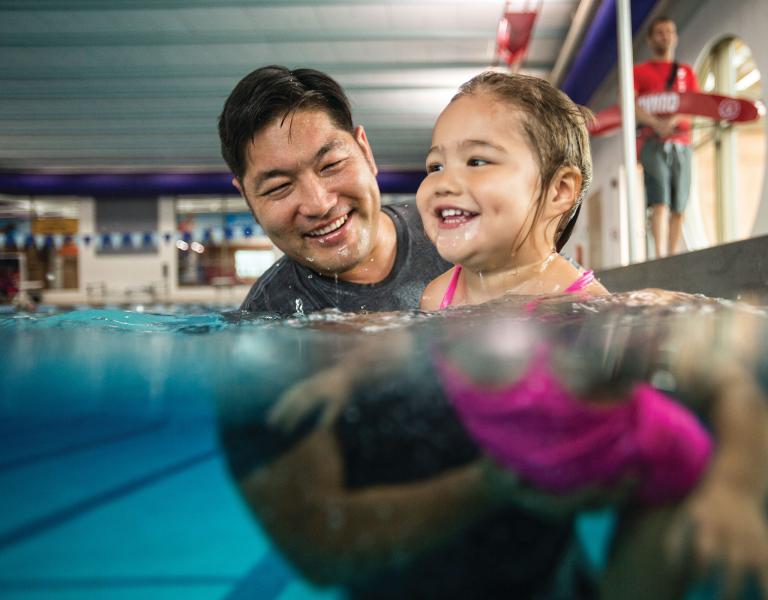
[219,66,449,315]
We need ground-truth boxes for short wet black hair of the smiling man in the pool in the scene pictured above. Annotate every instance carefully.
[219,65,354,180]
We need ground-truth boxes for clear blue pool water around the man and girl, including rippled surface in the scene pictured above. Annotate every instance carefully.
[0,296,766,600]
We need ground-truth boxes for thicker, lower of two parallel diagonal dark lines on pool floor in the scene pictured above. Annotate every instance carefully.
[0,448,219,552]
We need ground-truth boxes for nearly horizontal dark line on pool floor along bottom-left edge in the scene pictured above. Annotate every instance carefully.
[0,575,237,592]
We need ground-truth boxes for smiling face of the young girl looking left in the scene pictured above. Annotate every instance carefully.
[416,93,551,272]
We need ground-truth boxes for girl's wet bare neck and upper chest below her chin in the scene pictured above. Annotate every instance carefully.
[462,249,558,304]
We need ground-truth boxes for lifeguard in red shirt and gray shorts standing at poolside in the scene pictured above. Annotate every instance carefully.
[634,16,699,258]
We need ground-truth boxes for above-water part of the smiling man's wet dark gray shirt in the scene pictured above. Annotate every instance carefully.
[240,201,451,316]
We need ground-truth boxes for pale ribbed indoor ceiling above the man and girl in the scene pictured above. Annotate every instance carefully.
[0,0,579,172]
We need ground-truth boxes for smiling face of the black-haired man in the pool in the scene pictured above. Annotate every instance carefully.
[235,110,381,275]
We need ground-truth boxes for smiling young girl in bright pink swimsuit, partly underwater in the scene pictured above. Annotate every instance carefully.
[416,73,711,503]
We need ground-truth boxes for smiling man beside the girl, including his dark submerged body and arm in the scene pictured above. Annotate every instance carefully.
[219,66,593,598]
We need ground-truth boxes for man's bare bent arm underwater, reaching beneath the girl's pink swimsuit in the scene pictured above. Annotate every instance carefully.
[240,429,503,585]
